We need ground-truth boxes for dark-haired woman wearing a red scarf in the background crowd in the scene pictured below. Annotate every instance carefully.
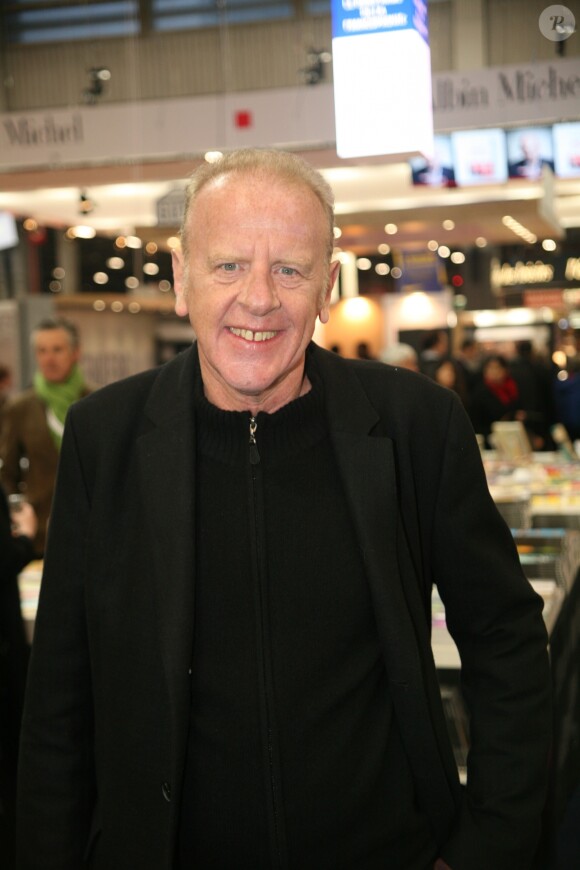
[469,353,520,449]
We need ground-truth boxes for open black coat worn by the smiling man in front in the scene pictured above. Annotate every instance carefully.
[18,346,551,870]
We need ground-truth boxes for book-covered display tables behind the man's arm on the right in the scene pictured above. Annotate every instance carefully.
[432,450,580,867]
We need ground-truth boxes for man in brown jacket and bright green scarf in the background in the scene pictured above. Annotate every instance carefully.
[0,317,89,558]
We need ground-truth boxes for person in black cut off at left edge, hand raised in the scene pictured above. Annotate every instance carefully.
[0,487,37,870]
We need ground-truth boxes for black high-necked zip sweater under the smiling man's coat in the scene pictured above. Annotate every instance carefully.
[178,362,435,870]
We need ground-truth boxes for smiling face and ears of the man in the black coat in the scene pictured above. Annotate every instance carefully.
[174,175,338,413]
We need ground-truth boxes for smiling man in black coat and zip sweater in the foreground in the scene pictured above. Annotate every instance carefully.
[18,151,551,870]
